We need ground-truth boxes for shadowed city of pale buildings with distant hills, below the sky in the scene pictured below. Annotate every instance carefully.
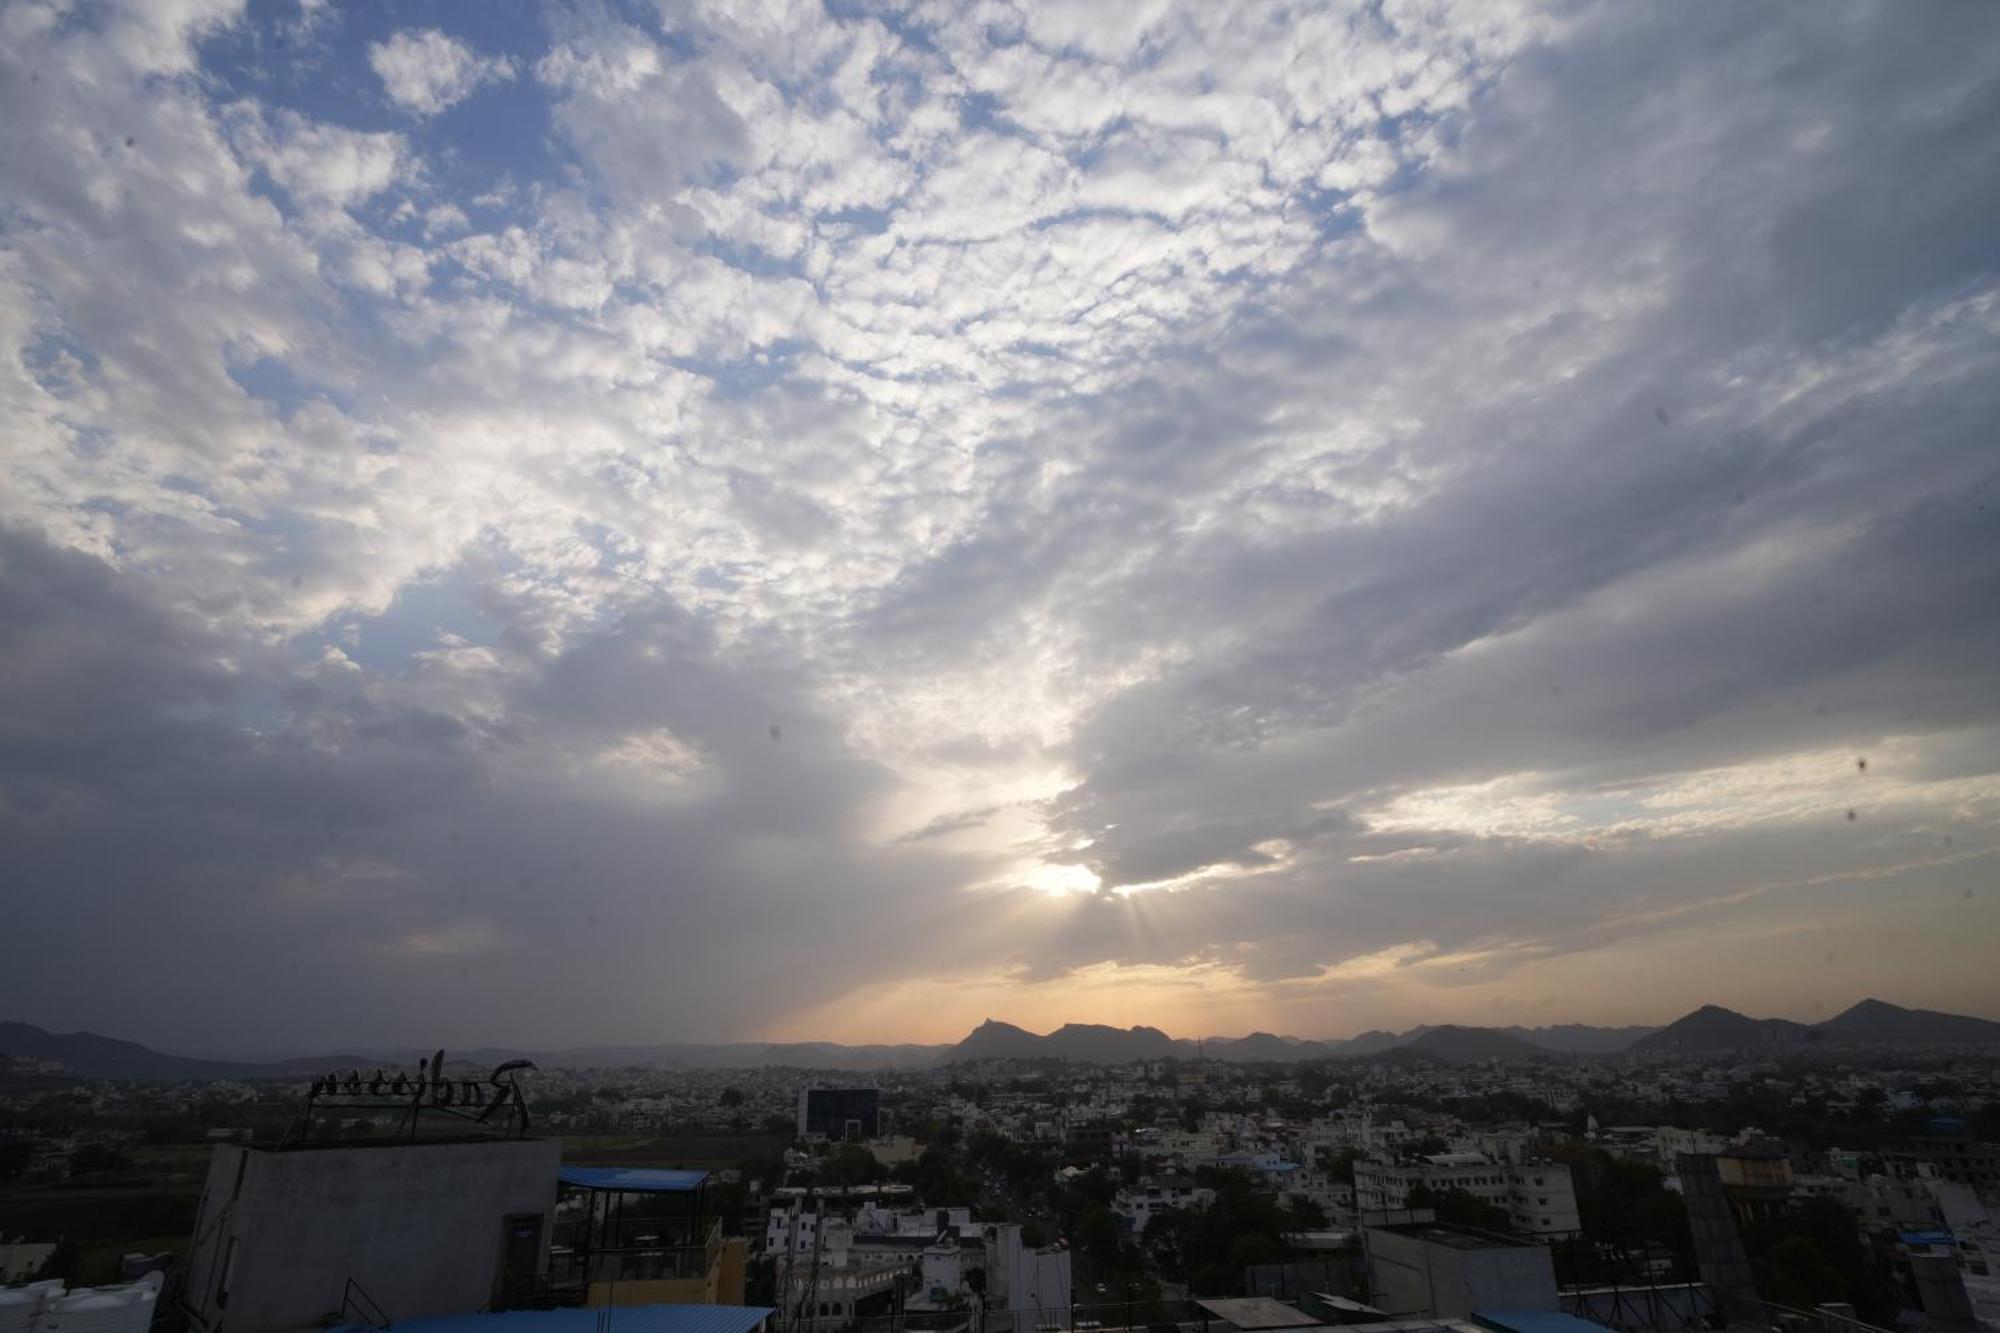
[0,999,2000,1333]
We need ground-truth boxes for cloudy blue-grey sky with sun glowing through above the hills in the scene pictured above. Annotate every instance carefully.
[0,0,2000,1051]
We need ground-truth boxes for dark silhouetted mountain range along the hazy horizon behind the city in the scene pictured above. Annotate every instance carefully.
[0,999,2000,1081]
